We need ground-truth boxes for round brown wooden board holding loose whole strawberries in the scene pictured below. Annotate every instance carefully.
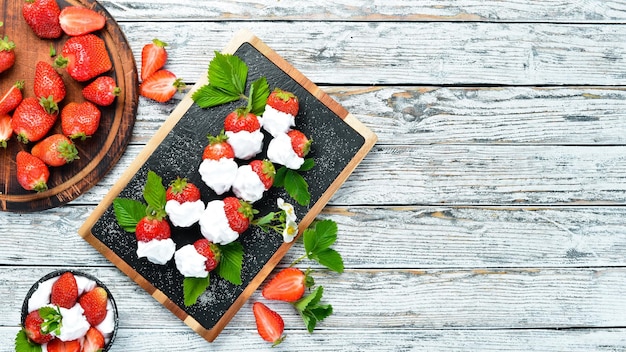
[0,0,138,212]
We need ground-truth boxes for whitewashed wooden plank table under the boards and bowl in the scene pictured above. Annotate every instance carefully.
[0,0,626,352]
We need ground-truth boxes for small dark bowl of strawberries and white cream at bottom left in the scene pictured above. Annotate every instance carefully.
[15,270,119,352]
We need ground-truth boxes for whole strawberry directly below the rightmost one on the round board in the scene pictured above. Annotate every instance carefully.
[61,101,102,140]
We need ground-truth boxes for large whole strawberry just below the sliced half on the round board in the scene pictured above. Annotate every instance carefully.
[54,33,113,82]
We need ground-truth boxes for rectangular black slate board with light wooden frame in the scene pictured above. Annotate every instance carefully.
[79,30,376,341]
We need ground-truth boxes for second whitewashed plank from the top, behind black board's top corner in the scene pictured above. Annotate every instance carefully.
[113,22,626,85]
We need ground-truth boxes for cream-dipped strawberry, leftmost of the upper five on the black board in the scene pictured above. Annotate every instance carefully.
[198,131,238,195]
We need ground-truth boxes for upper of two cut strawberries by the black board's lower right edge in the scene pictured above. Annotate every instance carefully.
[261,267,312,302]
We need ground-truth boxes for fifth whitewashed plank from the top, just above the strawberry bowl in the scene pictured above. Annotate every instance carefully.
[0,206,626,269]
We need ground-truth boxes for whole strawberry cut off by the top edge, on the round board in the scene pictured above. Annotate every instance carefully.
[22,0,62,39]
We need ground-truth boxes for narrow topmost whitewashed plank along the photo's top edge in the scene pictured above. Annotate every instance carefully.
[100,0,626,23]
